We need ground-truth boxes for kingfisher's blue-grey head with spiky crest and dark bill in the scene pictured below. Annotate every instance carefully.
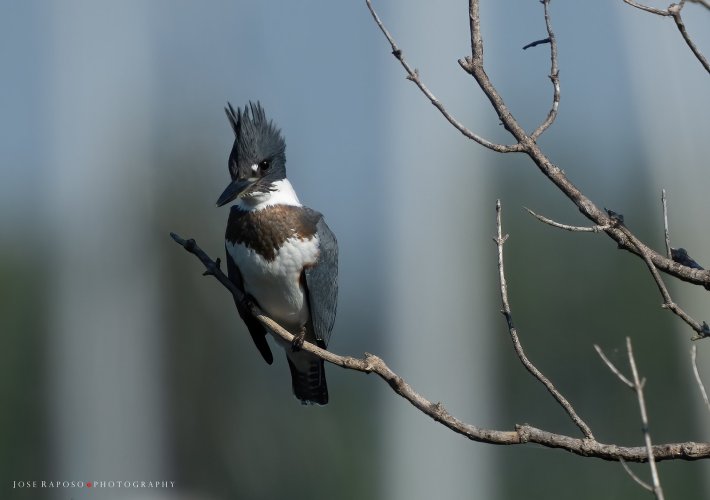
[217,102,286,207]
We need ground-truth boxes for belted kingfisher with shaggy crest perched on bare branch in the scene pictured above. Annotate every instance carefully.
[217,102,338,405]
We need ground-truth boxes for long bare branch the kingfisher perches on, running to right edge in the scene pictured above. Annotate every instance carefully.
[170,233,710,463]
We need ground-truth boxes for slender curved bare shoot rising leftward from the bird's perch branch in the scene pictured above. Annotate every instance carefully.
[494,200,594,439]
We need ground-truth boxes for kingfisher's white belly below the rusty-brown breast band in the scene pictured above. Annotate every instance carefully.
[227,237,318,334]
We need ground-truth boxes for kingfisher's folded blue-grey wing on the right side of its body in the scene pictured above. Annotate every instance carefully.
[304,211,338,347]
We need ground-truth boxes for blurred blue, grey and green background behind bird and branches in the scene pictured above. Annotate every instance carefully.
[0,0,710,500]
